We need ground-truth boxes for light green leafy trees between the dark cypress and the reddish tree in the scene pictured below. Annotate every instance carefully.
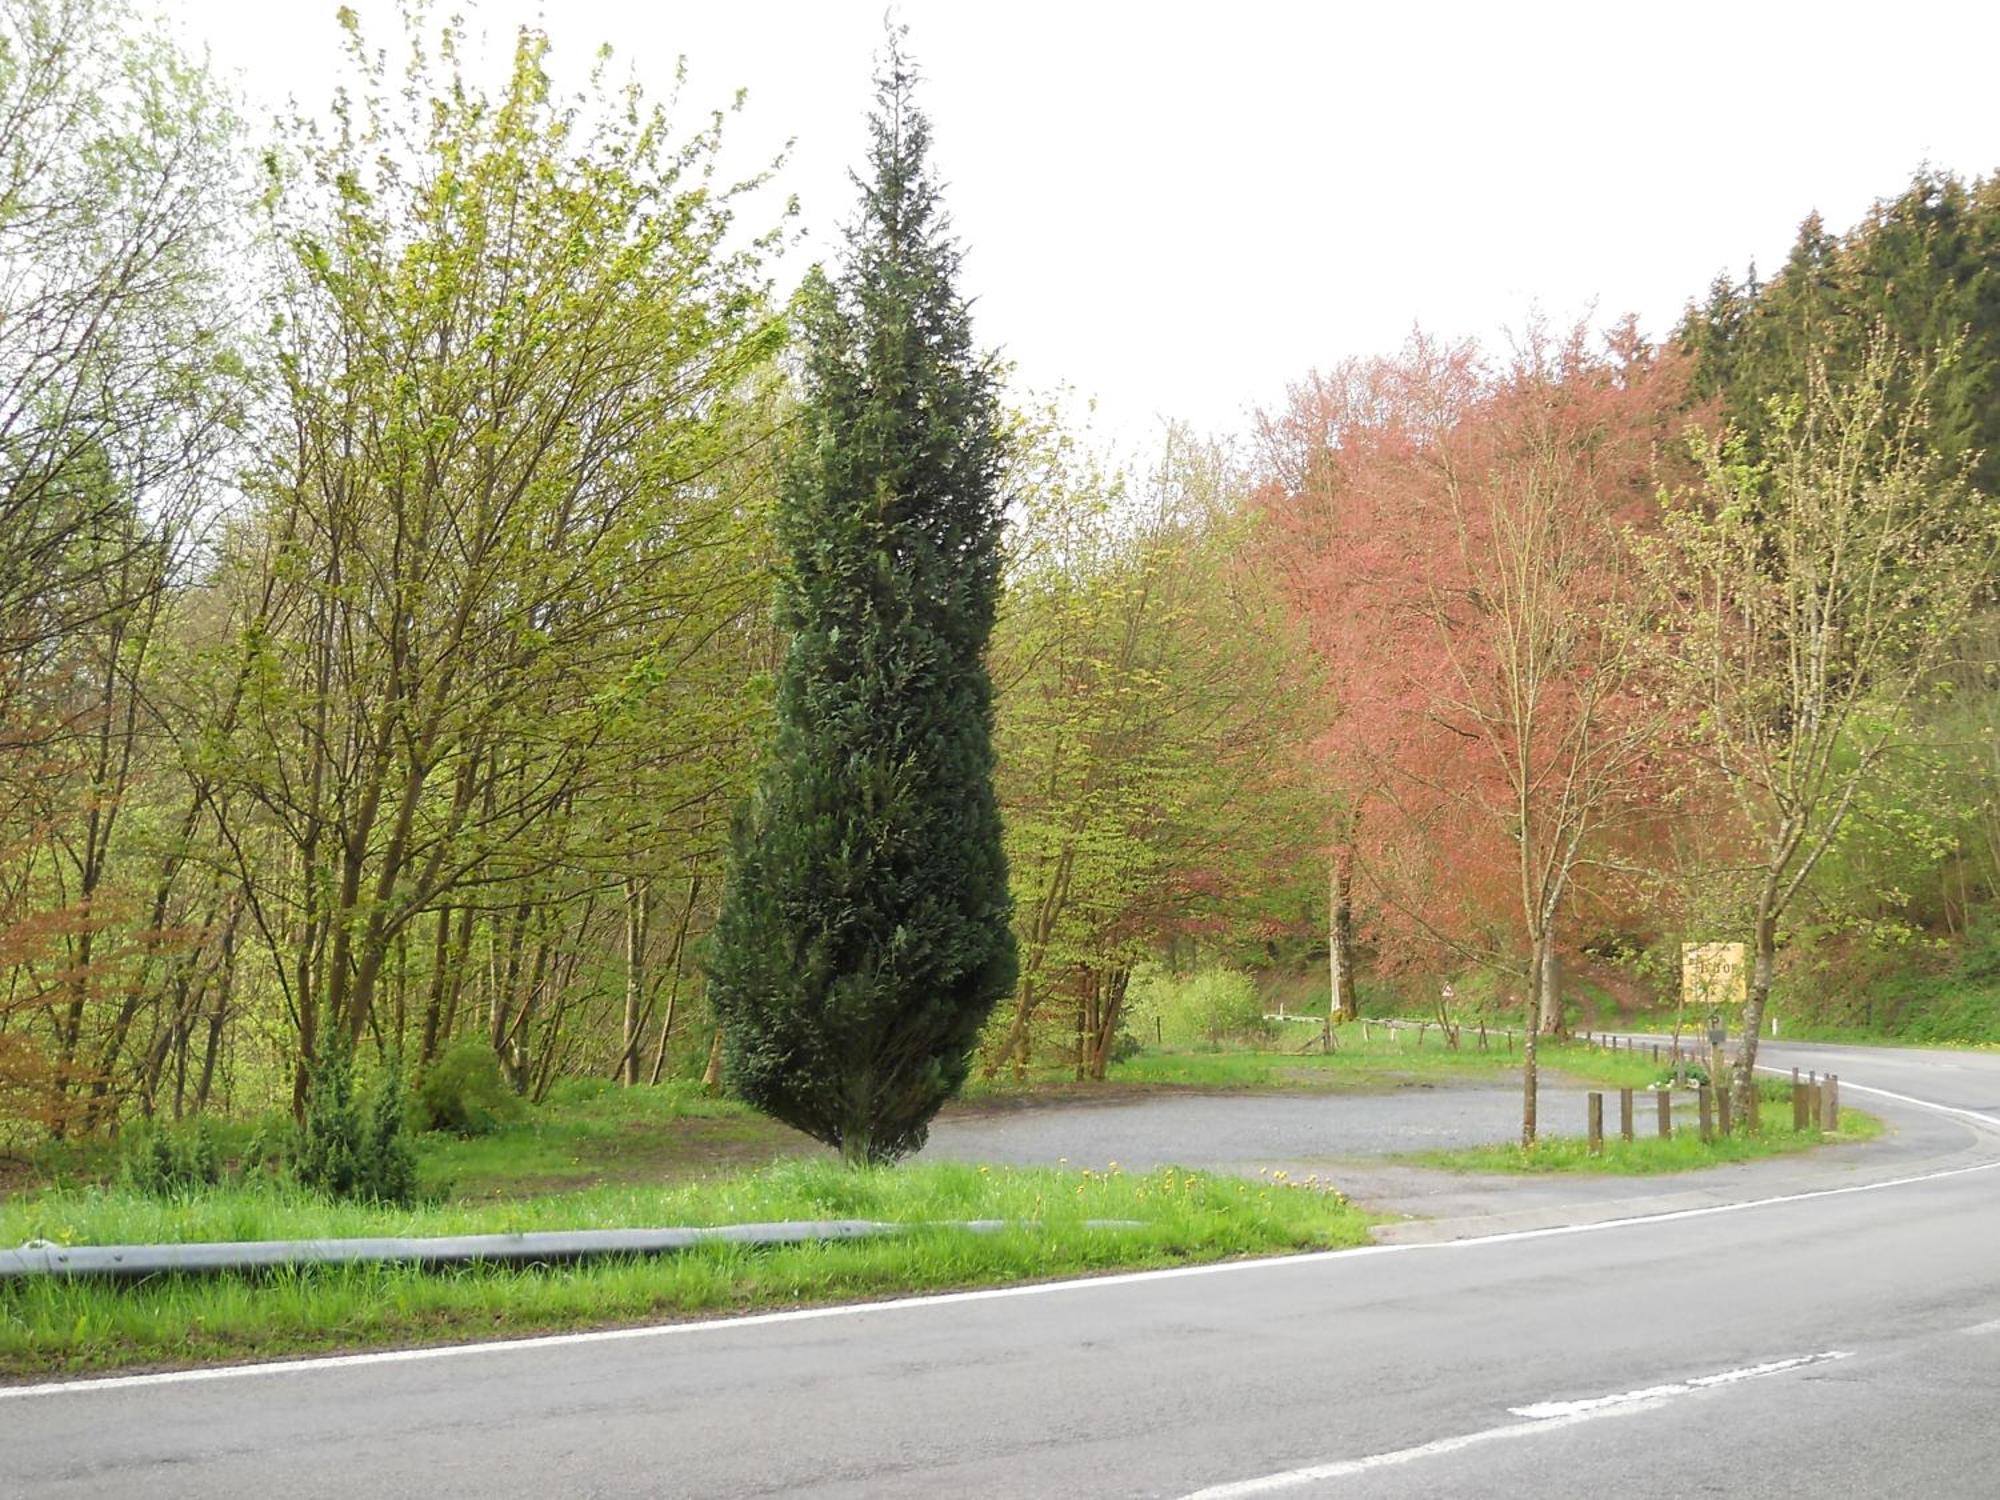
[988,414,1316,1076]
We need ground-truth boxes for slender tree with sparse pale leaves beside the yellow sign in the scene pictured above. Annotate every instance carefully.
[1656,330,2000,1096]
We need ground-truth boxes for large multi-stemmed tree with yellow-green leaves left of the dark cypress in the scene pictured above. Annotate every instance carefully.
[174,0,780,1092]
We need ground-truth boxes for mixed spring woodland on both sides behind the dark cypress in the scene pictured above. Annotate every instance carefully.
[0,0,2000,1146]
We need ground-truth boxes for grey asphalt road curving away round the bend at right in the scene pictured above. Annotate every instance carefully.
[0,1048,2000,1498]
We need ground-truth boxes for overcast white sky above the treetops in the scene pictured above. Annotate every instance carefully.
[162,0,2000,450]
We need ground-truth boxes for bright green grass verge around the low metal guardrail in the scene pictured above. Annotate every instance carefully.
[0,1160,1370,1378]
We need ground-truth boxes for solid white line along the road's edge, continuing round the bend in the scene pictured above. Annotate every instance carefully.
[0,1070,2000,1400]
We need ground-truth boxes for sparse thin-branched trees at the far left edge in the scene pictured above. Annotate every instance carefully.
[0,0,248,1142]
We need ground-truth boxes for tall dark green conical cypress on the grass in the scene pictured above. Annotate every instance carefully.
[710,36,1014,1162]
